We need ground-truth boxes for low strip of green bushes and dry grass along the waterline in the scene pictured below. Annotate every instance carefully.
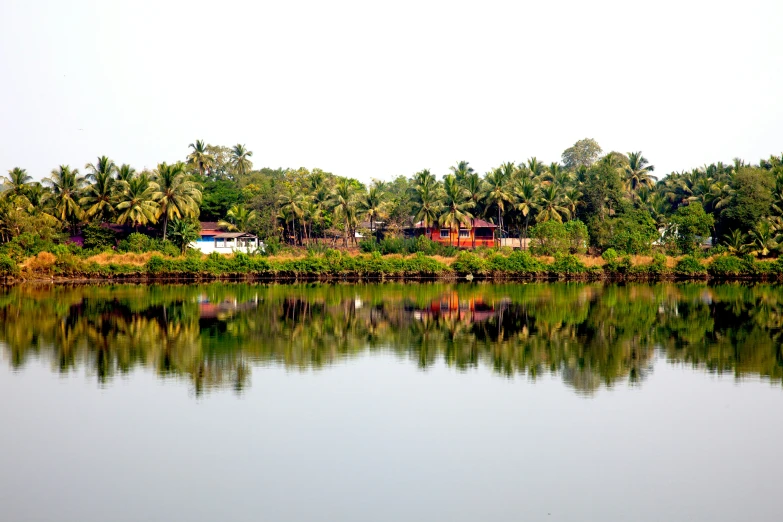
[0,249,783,282]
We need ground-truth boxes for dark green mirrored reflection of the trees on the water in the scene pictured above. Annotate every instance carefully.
[0,284,783,393]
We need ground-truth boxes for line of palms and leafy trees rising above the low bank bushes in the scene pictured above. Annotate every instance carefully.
[0,138,783,257]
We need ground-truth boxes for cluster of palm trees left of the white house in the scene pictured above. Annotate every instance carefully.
[3,156,201,239]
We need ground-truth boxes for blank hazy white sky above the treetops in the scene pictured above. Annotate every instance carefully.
[0,0,783,181]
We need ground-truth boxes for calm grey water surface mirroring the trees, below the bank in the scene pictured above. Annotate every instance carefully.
[0,284,783,522]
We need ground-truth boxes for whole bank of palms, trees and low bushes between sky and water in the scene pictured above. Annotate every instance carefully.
[0,138,783,282]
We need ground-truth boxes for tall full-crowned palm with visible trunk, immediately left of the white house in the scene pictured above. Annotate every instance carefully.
[152,161,201,241]
